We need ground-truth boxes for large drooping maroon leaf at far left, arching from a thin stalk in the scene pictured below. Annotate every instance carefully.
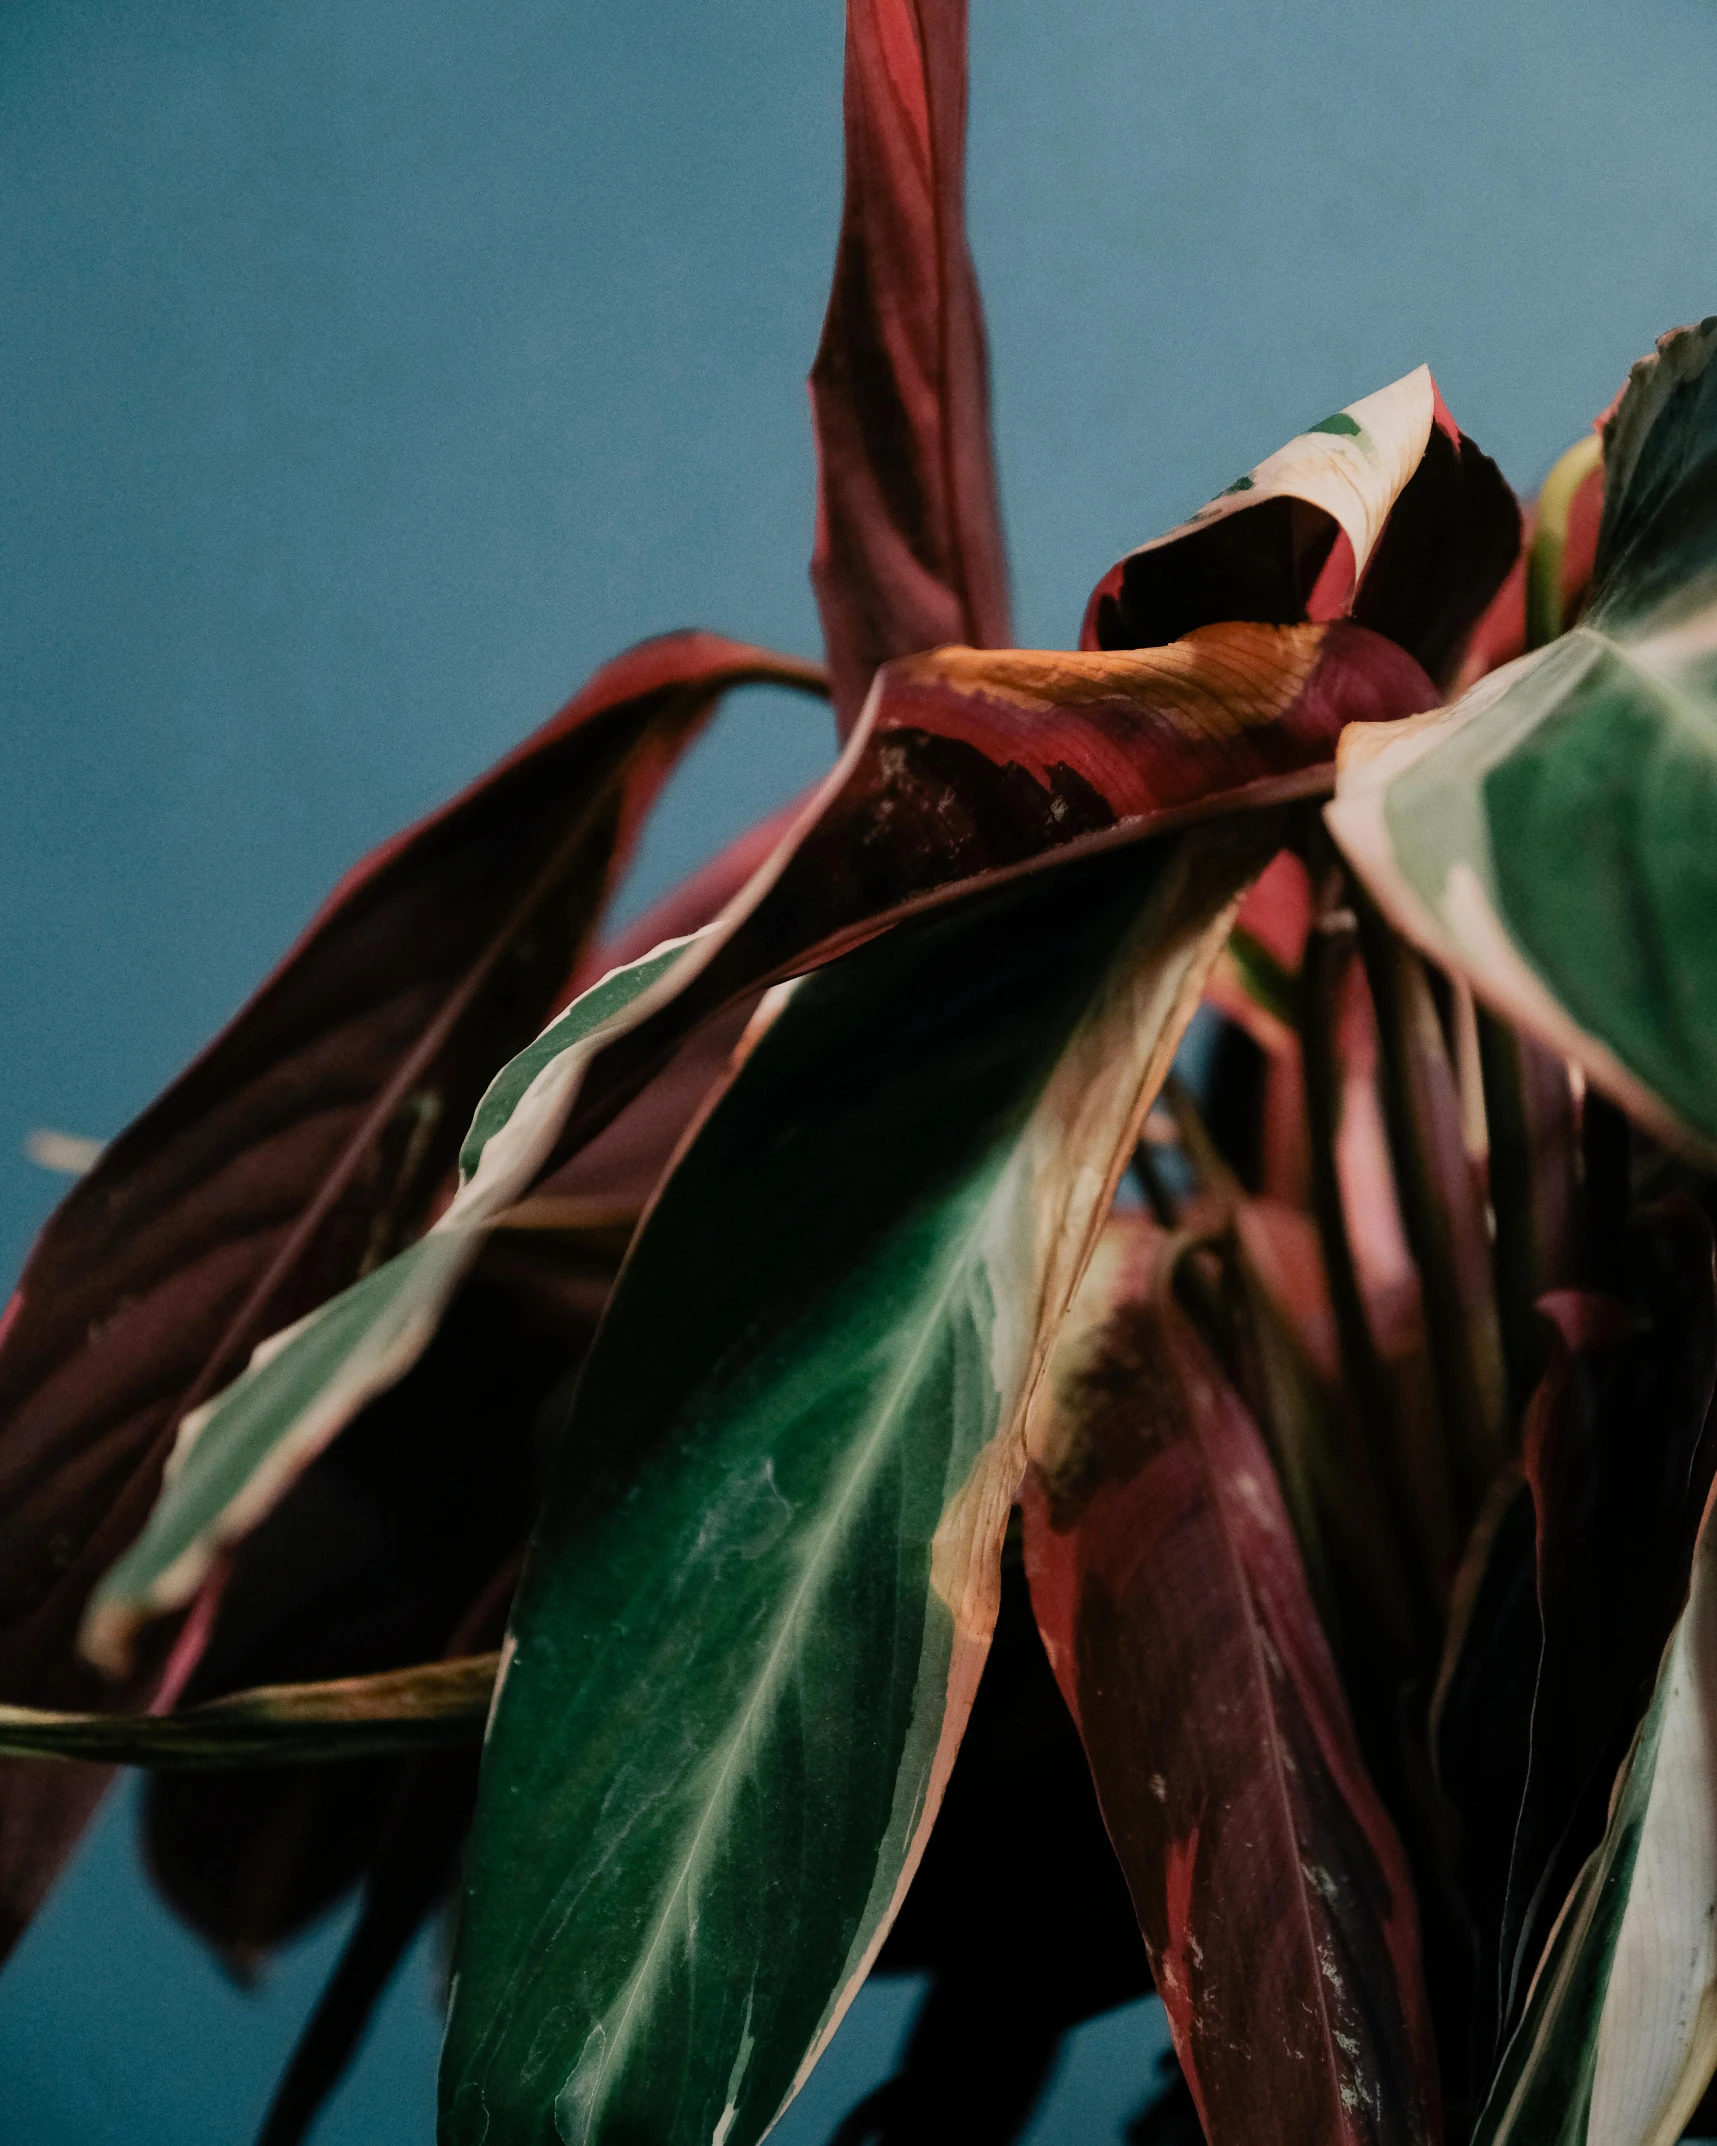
[0,633,820,1951]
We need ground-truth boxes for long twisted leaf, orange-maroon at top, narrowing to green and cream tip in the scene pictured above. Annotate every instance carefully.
[82,624,1450,1670]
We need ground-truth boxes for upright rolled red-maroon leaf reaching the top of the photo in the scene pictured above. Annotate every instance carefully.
[811,0,1013,736]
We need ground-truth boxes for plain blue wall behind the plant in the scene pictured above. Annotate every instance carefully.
[0,0,1717,2146]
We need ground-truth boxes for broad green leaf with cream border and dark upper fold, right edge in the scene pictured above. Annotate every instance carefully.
[1329,320,1717,1150]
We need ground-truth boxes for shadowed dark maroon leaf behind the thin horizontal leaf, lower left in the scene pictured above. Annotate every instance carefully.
[144,1240,575,1970]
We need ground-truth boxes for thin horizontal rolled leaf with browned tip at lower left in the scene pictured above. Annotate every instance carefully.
[0,1655,500,1768]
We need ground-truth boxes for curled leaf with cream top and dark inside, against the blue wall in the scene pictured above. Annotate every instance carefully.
[1084,365,1520,680]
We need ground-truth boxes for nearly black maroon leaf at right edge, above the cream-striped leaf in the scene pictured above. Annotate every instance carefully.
[1500,1195,1717,2030]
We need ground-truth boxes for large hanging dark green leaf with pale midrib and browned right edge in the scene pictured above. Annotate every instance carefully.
[442,822,1279,2146]
